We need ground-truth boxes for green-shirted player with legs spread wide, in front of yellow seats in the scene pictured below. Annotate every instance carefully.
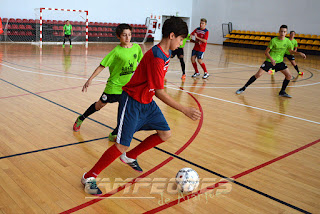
[236,25,306,98]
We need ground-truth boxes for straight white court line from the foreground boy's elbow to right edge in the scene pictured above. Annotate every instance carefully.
[167,86,320,125]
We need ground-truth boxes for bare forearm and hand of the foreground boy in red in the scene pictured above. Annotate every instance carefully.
[155,89,201,120]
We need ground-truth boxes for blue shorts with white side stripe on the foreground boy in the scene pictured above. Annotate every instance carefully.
[116,91,170,146]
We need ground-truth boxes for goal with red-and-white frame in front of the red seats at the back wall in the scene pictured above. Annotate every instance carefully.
[35,8,88,46]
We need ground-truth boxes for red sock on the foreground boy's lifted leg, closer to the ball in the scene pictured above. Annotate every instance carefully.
[126,134,164,159]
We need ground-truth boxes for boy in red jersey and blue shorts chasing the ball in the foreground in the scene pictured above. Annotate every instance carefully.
[81,17,201,194]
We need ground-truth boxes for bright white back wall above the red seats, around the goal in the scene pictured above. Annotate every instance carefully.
[0,0,192,24]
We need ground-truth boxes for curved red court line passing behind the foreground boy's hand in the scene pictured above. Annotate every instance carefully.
[61,93,203,214]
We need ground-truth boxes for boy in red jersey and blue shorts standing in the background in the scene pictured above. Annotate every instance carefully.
[191,18,209,79]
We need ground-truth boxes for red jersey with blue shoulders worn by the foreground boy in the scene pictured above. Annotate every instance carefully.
[122,45,171,104]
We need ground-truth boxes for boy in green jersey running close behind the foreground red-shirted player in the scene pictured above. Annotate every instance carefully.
[73,24,143,141]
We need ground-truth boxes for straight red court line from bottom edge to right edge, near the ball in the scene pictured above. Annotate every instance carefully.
[145,139,320,214]
